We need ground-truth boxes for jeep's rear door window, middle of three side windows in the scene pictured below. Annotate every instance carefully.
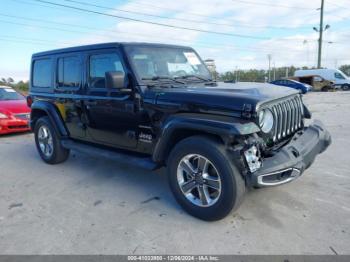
[57,56,81,87]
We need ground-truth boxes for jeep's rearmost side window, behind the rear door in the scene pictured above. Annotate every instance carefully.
[32,59,52,88]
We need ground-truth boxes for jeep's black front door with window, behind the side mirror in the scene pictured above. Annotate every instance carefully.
[84,48,139,148]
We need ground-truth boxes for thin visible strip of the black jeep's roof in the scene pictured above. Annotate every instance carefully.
[33,42,192,57]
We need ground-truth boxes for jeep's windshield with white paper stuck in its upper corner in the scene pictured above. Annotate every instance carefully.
[126,46,211,81]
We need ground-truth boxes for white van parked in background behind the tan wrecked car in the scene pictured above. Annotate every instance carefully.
[294,69,350,90]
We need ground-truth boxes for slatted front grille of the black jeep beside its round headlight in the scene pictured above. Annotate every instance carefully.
[270,95,303,142]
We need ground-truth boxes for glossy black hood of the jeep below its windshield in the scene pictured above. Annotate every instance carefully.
[145,83,299,112]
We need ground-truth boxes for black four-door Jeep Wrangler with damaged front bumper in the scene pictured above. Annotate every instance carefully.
[28,43,331,220]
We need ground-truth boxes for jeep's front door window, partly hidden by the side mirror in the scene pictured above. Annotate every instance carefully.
[89,53,125,88]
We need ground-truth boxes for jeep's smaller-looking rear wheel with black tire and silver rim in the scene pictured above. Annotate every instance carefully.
[34,116,70,165]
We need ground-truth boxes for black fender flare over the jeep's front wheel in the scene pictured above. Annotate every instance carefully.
[152,114,260,162]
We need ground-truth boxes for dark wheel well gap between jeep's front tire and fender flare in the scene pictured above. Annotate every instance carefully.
[160,129,225,163]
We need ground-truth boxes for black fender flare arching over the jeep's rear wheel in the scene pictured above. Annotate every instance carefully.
[30,100,69,137]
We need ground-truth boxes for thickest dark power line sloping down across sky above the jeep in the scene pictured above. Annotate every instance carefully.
[29,0,269,39]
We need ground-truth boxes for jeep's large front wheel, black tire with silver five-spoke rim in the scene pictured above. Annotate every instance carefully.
[167,136,246,221]
